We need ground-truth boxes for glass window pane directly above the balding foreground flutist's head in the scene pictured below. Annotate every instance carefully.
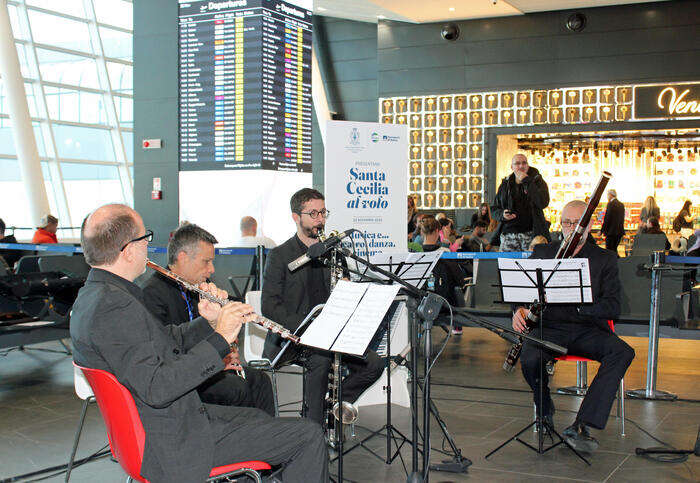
[61,163,124,224]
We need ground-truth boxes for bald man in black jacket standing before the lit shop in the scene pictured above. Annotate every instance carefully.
[491,154,550,252]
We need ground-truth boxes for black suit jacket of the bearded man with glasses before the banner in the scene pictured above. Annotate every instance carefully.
[261,235,330,358]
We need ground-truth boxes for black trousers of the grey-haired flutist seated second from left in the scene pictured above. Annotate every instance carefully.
[197,368,275,416]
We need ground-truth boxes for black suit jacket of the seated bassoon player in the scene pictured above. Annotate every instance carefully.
[530,242,622,331]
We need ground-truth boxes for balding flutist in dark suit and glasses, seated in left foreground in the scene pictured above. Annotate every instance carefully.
[70,205,328,483]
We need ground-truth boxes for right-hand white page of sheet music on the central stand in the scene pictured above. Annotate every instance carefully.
[331,284,401,355]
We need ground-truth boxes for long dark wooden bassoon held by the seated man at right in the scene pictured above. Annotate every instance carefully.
[503,171,612,373]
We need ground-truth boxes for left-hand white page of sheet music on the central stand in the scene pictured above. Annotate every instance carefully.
[301,280,368,350]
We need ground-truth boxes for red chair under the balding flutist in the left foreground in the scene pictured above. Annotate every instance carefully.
[74,363,271,483]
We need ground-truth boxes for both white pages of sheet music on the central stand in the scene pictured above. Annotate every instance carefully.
[301,280,401,356]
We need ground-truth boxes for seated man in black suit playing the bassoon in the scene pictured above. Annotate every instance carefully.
[513,201,634,452]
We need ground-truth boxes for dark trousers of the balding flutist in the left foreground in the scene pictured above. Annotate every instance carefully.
[206,405,328,483]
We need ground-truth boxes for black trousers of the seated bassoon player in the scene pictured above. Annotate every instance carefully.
[520,322,634,429]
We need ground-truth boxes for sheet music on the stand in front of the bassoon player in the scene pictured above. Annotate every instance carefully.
[498,258,593,304]
